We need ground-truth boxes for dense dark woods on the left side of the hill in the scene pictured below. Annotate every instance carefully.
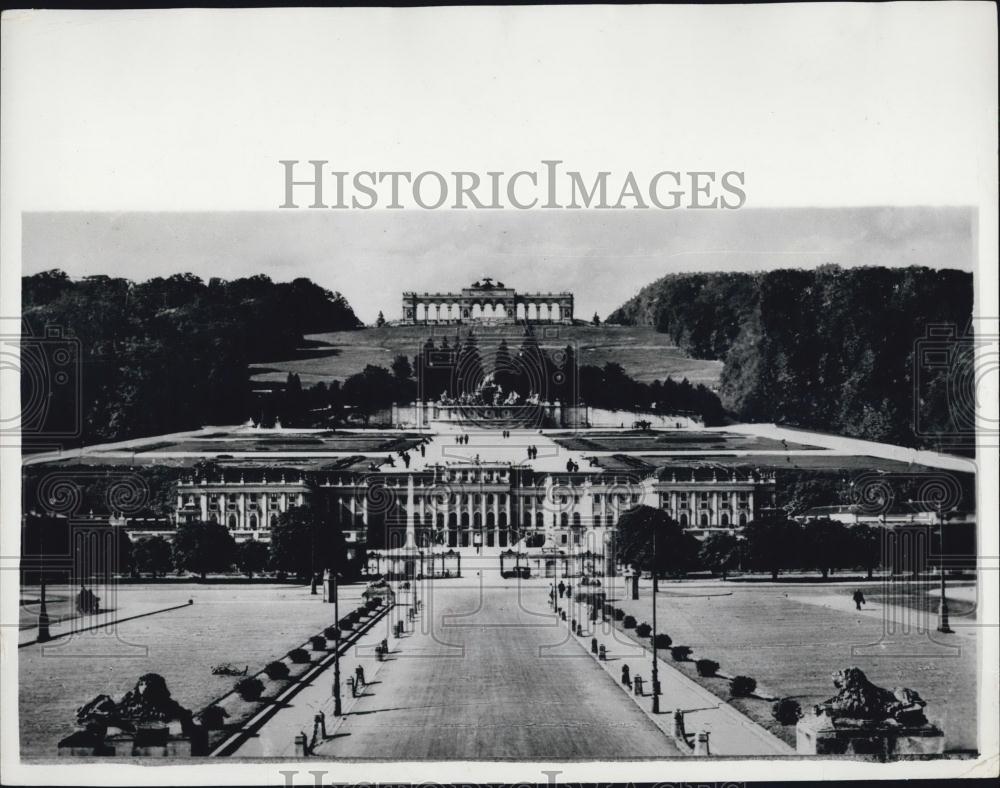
[21,269,361,443]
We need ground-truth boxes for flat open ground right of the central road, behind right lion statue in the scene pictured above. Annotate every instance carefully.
[600,581,976,750]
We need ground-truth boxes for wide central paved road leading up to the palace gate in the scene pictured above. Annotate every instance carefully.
[254,576,682,760]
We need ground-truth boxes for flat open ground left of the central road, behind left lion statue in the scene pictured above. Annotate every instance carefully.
[17,583,372,758]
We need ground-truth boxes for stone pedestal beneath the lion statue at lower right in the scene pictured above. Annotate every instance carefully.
[795,714,944,761]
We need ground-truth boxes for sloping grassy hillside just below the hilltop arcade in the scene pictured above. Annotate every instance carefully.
[251,325,722,387]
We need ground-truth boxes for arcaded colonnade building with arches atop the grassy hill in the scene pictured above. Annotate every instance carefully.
[401,277,573,325]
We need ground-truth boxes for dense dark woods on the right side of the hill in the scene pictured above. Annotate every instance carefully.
[607,265,974,447]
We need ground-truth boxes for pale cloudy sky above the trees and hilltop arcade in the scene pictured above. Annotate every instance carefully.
[22,207,976,323]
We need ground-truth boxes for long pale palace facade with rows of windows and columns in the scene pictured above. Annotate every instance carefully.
[176,462,775,552]
